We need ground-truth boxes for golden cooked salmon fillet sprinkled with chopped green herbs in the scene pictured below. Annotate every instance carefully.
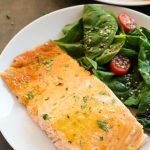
[1,41,144,150]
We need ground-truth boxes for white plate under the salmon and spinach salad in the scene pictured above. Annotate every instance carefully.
[0,5,150,150]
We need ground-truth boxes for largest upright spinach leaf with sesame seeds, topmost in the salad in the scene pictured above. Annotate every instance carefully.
[83,5,118,59]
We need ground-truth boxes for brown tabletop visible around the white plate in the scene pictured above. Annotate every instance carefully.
[0,0,150,150]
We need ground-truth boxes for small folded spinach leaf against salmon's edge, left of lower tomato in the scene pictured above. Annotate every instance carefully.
[78,57,97,70]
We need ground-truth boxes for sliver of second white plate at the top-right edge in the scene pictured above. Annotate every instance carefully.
[95,0,150,6]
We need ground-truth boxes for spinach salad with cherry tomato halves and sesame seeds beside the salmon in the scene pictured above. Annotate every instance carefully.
[55,4,150,132]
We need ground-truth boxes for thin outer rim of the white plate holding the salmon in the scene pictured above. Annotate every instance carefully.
[0,3,150,150]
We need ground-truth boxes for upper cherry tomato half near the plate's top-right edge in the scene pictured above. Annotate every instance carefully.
[118,12,136,32]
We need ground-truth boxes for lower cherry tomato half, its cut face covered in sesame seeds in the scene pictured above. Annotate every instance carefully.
[110,55,131,75]
